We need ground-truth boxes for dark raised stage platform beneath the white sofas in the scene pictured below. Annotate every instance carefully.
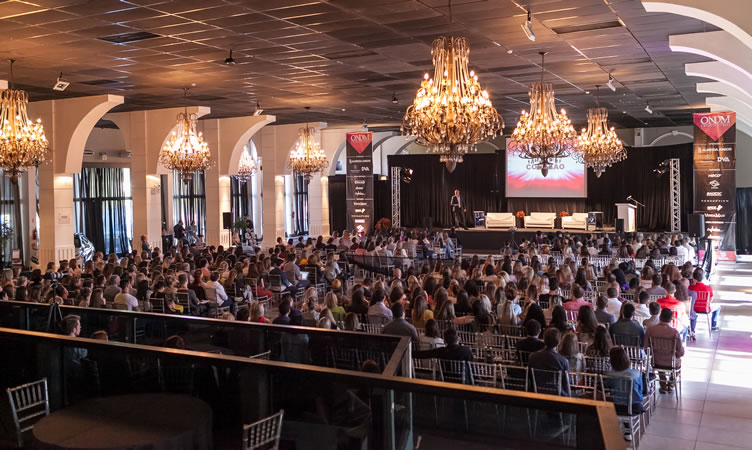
[456,227,616,253]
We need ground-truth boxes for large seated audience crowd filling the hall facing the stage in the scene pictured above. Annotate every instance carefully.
[0,230,719,436]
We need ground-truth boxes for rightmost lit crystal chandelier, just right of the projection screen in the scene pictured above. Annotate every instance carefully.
[576,86,627,178]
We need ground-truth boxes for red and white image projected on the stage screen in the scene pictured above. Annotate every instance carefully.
[506,152,587,198]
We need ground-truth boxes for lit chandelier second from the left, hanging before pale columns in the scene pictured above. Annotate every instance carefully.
[159,88,212,183]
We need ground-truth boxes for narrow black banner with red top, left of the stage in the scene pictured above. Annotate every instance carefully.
[345,131,373,235]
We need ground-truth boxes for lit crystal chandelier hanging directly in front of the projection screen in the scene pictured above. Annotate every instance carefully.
[509,52,577,177]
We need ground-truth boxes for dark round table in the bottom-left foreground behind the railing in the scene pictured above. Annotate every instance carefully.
[33,394,214,450]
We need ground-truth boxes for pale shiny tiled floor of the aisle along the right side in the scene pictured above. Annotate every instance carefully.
[640,263,752,450]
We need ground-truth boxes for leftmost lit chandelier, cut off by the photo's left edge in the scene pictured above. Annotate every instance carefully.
[0,59,49,183]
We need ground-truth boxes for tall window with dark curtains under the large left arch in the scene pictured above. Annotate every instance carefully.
[73,167,133,255]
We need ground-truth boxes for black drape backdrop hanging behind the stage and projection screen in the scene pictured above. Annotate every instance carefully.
[376,144,693,230]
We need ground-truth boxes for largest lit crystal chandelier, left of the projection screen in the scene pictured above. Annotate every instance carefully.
[402,1,504,170]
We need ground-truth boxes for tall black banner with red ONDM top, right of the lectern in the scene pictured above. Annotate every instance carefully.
[693,112,736,261]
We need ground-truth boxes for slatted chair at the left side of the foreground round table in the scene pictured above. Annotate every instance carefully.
[6,378,50,447]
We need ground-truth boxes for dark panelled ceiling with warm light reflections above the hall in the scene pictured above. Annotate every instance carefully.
[0,0,716,132]
